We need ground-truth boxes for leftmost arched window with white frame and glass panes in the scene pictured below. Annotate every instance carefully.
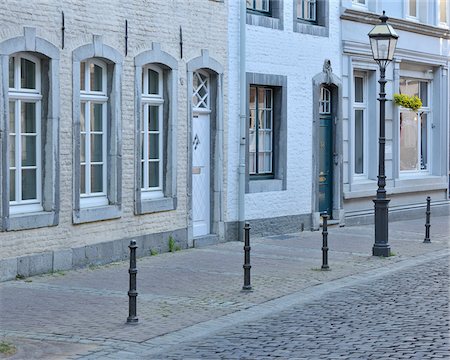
[8,53,42,214]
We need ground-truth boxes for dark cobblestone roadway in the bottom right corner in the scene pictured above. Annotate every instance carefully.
[152,256,450,359]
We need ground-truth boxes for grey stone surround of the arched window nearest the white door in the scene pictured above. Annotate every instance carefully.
[134,43,178,215]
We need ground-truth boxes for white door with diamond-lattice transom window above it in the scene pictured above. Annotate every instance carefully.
[192,71,211,237]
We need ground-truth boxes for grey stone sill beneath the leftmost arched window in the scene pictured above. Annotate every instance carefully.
[5,211,59,231]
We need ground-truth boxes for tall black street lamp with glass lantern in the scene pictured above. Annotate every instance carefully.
[369,11,398,256]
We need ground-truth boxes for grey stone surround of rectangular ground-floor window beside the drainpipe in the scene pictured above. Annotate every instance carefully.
[245,73,287,193]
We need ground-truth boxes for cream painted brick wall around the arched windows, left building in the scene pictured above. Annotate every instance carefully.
[0,0,228,258]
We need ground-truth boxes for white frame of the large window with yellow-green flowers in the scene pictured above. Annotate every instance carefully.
[398,77,432,178]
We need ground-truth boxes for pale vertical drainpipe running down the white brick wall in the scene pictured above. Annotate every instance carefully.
[238,0,247,241]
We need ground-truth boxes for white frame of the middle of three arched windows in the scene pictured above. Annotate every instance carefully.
[79,58,108,208]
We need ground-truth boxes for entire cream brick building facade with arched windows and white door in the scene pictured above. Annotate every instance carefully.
[0,0,228,279]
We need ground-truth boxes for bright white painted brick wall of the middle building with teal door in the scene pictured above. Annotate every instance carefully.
[226,0,341,221]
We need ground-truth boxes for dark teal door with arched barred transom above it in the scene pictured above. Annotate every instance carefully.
[318,86,333,216]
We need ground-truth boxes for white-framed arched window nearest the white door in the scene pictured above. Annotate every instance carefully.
[140,65,165,199]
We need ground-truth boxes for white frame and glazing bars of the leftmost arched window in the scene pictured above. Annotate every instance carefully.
[8,53,43,215]
